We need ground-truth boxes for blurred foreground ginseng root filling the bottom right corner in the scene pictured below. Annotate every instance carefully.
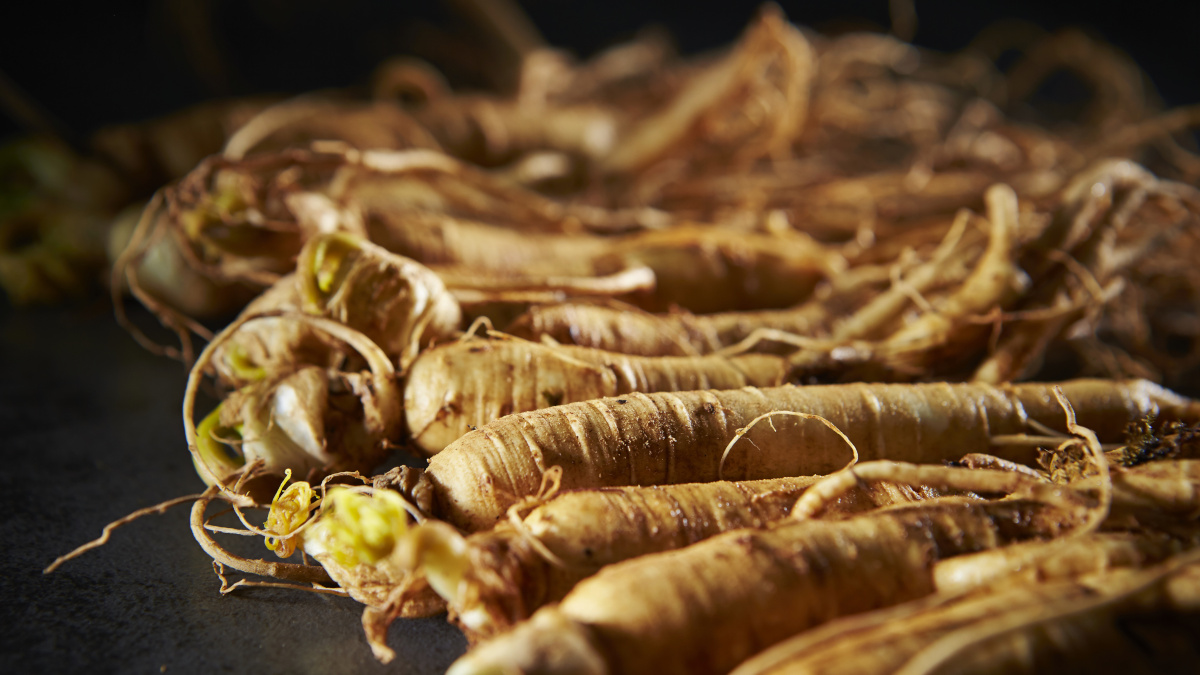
[733,552,1200,675]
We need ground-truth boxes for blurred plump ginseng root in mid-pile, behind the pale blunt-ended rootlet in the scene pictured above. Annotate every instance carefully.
[365,211,846,312]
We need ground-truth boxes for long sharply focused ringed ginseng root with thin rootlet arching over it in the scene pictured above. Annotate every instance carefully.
[426,380,1200,531]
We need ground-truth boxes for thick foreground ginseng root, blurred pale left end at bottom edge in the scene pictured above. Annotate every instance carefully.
[449,485,1086,675]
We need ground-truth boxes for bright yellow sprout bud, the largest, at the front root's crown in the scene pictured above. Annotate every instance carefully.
[310,488,408,567]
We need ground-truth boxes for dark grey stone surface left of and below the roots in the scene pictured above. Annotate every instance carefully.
[0,304,466,674]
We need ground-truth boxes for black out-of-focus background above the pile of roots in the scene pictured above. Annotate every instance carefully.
[0,0,1200,137]
